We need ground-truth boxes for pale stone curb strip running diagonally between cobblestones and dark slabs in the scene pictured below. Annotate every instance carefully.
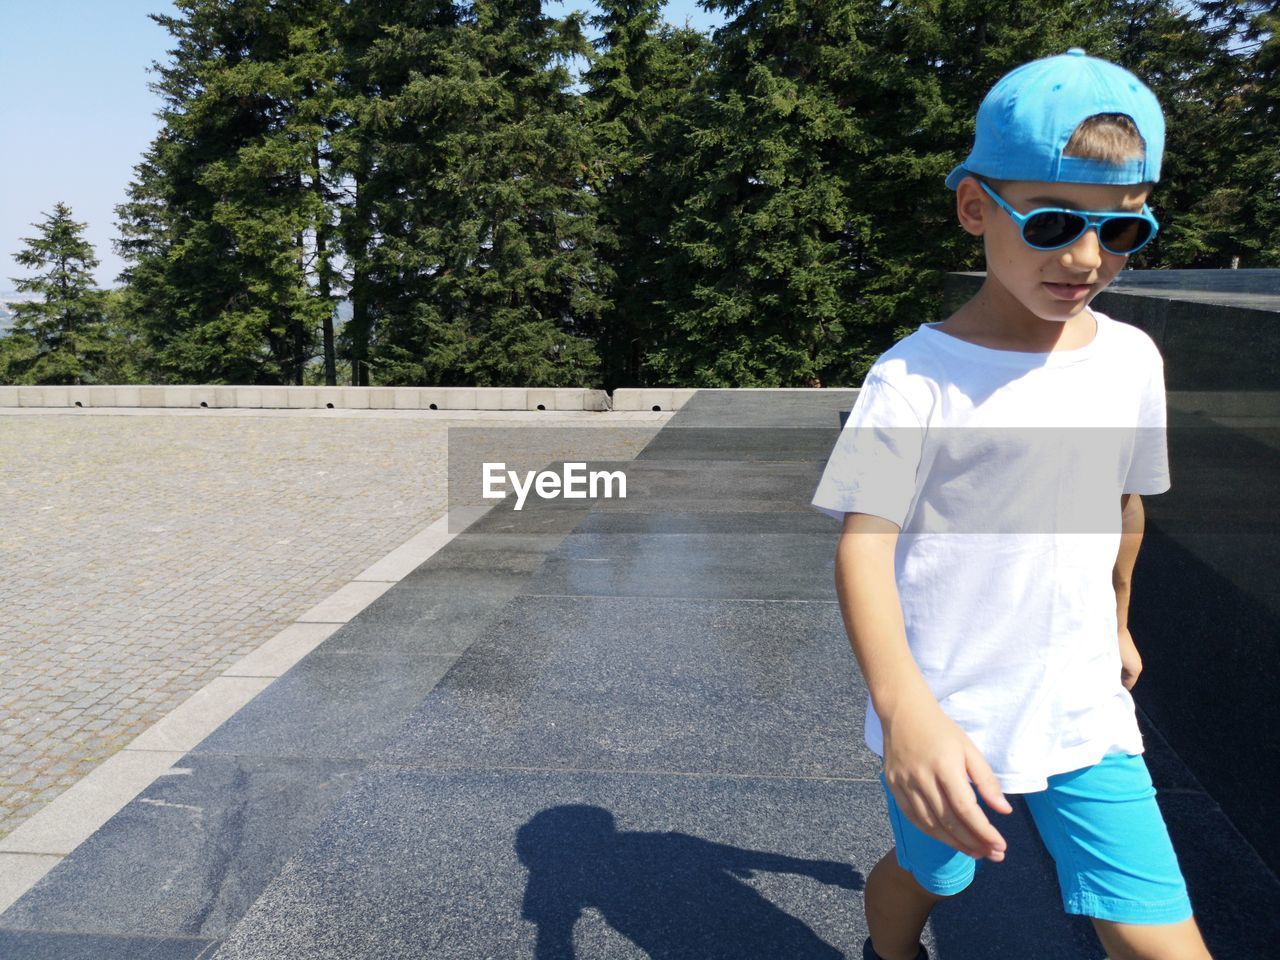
[0,504,492,913]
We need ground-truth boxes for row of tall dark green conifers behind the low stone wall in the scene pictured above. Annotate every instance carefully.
[0,0,1280,390]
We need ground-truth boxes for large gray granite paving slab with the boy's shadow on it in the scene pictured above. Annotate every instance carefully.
[207,764,1098,960]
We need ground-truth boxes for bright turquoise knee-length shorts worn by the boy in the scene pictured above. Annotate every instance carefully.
[879,753,1192,924]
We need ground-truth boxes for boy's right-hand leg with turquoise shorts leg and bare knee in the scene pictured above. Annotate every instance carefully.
[1025,753,1210,960]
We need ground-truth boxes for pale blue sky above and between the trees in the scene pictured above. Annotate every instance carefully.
[0,0,724,292]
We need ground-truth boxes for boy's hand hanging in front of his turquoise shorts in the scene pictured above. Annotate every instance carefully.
[883,698,1014,863]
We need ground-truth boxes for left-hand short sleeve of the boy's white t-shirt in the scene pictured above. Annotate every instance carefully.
[810,372,924,529]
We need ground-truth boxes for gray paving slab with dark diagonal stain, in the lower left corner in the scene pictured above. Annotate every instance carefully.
[0,756,365,942]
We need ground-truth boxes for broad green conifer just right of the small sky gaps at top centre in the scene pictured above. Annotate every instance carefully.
[645,0,881,387]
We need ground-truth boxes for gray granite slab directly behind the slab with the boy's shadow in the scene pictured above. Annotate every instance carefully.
[380,596,878,778]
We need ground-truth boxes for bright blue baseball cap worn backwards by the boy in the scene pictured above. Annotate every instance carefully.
[947,46,1165,189]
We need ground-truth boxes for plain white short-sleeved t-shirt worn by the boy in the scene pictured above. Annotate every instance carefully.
[813,310,1170,794]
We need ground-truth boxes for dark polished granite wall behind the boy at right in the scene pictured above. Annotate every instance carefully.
[938,270,1280,872]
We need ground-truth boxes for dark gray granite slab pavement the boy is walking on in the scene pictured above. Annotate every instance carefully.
[0,390,1280,960]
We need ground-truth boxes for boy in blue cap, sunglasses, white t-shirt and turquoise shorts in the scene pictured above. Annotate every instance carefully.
[813,47,1210,960]
